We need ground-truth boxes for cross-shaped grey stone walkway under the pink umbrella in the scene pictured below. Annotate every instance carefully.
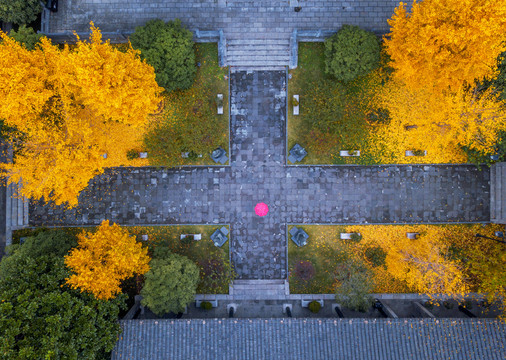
[30,71,490,279]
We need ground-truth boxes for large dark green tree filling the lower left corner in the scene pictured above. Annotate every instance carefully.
[0,231,125,360]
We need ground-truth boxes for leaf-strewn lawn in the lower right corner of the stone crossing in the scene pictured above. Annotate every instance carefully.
[288,224,502,294]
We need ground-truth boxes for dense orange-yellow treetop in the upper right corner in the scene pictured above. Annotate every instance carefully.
[385,0,506,91]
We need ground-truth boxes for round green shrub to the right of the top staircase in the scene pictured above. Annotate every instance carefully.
[325,25,381,82]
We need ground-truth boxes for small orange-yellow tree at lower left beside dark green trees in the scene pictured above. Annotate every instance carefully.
[65,220,150,300]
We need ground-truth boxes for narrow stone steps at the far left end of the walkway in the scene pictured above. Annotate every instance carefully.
[5,184,29,245]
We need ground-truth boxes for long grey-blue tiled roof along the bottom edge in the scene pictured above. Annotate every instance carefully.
[112,319,506,360]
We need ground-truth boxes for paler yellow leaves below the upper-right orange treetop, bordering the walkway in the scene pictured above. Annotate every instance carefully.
[370,81,506,163]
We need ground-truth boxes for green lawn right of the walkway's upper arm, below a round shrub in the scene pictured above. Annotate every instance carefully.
[287,43,381,164]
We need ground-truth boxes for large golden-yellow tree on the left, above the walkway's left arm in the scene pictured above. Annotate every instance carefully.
[0,24,161,206]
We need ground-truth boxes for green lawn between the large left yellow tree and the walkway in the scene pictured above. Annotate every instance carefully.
[144,43,229,166]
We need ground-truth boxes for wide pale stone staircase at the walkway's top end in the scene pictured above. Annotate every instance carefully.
[227,36,290,70]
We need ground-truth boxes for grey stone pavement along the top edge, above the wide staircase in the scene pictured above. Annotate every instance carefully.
[49,0,399,38]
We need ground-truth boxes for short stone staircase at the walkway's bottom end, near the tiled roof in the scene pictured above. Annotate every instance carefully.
[229,279,290,300]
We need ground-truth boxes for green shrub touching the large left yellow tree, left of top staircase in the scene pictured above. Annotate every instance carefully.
[130,19,197,91]
